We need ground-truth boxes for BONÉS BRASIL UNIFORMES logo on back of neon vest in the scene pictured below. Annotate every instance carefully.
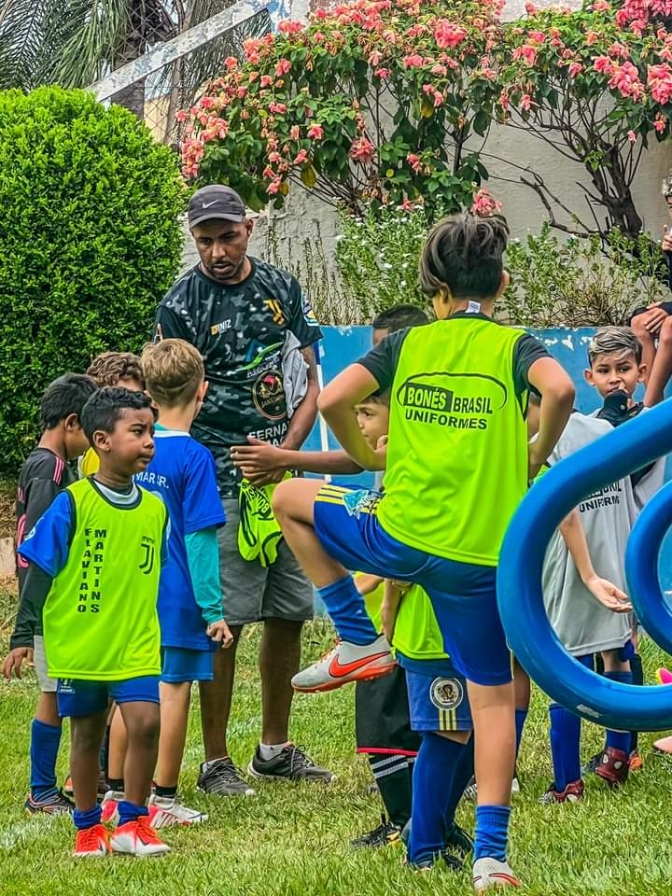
[396,372,507,430]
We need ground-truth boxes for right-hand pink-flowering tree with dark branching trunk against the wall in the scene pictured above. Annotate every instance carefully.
[497,0,672,238]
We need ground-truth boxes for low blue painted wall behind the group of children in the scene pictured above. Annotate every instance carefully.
[305,327,672,594]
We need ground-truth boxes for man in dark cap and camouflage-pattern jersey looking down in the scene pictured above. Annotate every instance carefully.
[156,184,333,796]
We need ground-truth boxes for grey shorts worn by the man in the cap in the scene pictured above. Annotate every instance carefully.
[218,498,314,625]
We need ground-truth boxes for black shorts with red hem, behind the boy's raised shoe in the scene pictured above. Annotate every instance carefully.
[355,666,420,756]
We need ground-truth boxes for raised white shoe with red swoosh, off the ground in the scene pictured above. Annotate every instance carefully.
[292,635,396,693]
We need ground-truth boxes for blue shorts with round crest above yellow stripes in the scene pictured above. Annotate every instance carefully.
[406,669,473,732]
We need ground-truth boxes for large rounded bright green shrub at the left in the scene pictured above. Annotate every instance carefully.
[0,87,184,473]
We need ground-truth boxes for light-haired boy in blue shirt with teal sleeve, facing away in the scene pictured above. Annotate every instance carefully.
[136,339,233,827]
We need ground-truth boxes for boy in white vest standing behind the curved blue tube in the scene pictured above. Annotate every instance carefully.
[542,327,665,802]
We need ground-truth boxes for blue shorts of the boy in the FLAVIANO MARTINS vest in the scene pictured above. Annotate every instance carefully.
[56,675,160,718]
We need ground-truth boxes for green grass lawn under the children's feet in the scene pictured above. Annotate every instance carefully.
[0,587,672,896]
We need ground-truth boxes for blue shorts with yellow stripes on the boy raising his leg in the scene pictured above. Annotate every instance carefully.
[314,485,512,685]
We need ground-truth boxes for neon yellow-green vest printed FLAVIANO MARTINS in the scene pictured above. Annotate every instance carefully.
[43,479,167,681]
